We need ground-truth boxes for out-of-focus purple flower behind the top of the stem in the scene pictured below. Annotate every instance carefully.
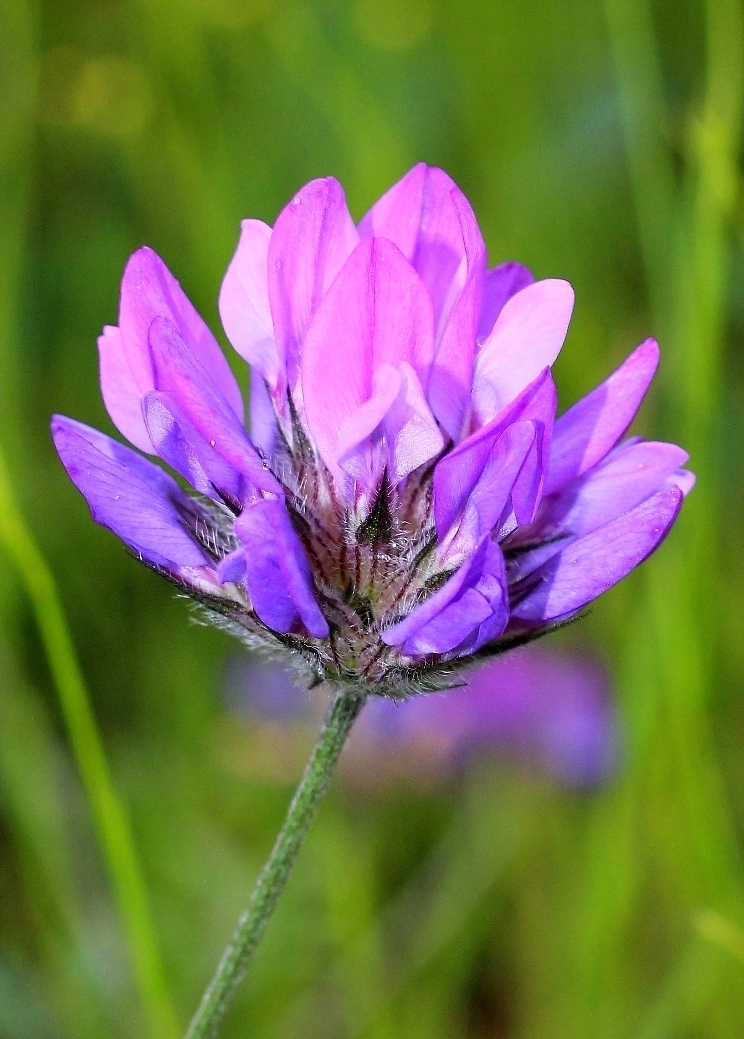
[227,648,619,788]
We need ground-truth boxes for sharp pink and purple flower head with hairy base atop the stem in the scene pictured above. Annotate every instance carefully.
[52,164,694,697]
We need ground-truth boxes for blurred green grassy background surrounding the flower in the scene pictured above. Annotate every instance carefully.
[0,0,744,1039]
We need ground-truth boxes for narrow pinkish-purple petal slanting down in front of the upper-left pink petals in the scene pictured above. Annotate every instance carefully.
[150,318,282,494]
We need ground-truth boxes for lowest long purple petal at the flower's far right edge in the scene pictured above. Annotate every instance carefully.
[511,487,683,622]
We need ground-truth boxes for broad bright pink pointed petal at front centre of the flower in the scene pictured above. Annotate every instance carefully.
[302,238,433,471]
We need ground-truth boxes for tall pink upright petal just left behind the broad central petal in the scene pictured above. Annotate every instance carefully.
[268,177,358,390]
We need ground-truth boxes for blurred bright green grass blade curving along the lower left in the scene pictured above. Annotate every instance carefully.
[0,453,177,1039]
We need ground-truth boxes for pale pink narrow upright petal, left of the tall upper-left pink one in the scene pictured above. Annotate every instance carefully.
[219,220,281,389]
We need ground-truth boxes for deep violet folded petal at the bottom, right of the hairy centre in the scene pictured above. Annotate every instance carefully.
[380,540,509,657]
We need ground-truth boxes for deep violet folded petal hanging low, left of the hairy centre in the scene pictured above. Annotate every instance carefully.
[235,499,329,639]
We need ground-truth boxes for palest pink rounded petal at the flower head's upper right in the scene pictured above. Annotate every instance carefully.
[473,279,574,423]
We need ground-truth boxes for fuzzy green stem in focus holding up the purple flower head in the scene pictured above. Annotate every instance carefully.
[186,693,364,1039]
